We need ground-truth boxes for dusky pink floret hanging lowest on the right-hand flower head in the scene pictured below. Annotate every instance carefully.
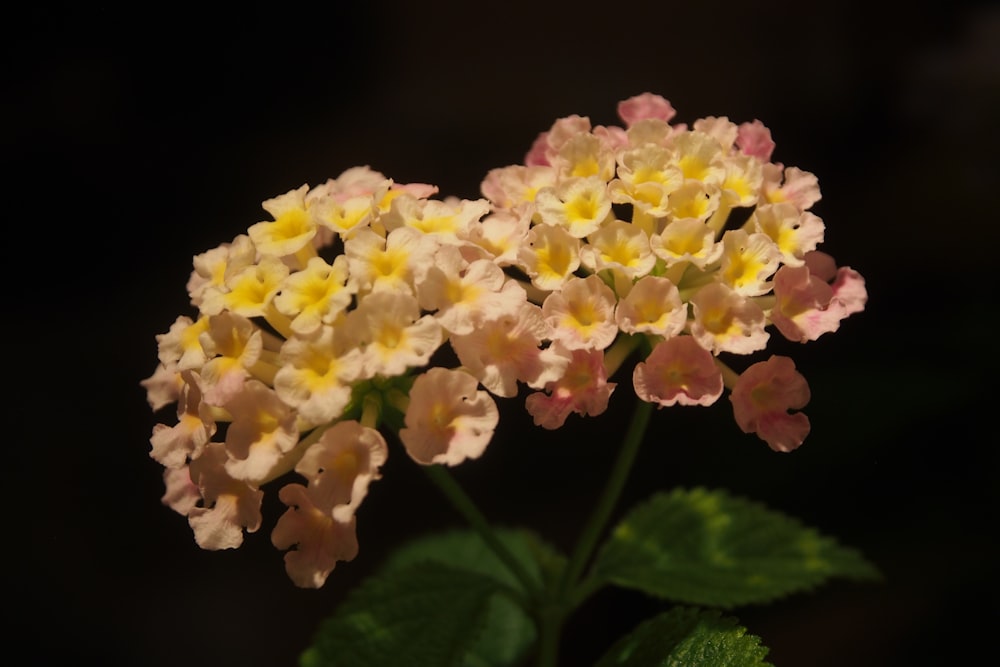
[729,356,809,452]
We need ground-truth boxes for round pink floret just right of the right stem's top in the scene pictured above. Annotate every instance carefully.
[632,336,722,407]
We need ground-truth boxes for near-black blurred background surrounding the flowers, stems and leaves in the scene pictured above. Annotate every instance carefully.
[0,0,1000,667]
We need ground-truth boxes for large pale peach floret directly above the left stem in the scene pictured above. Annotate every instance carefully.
[399,367,500,466]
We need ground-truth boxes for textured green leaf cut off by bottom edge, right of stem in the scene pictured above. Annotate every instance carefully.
[597,607,770,667]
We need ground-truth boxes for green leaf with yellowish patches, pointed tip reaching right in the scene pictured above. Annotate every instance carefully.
[593,488,879,607]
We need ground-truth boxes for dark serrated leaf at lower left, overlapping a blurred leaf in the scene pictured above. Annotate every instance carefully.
[300,562,501,667]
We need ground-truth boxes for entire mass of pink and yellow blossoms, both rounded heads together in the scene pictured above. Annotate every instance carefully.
[142,94,866,587]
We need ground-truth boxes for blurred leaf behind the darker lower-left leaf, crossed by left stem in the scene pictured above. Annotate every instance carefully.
[383,529,562,667]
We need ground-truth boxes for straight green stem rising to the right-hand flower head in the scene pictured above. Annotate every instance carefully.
[559,401,653,600]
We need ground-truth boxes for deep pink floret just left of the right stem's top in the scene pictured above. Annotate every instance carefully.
[525,350,616,430]
